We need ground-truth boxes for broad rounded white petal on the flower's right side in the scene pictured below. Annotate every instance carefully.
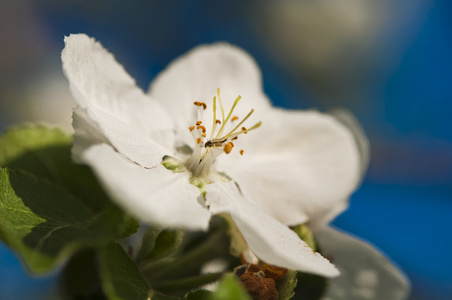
[217,109,360,225]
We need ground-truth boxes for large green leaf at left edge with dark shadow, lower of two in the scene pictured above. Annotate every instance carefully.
[0,169,132,274]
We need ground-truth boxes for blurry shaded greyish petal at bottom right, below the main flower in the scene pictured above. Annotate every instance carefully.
[315,226,409,300]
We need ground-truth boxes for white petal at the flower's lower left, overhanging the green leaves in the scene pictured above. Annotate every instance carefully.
[82,144,210,230]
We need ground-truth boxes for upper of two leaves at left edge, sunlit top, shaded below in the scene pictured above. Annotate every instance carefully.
[0,125,108,211]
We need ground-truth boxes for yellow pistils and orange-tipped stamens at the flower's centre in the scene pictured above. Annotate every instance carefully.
[186,89,262,177]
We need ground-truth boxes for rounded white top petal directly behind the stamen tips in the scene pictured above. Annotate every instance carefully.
[149,43,270,147]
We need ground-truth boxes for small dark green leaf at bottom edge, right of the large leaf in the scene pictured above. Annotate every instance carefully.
[98,243,151,300]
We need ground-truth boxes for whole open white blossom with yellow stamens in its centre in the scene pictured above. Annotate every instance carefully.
[62,35,406,292]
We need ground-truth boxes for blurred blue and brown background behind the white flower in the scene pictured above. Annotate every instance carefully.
[0,0,452,300]
